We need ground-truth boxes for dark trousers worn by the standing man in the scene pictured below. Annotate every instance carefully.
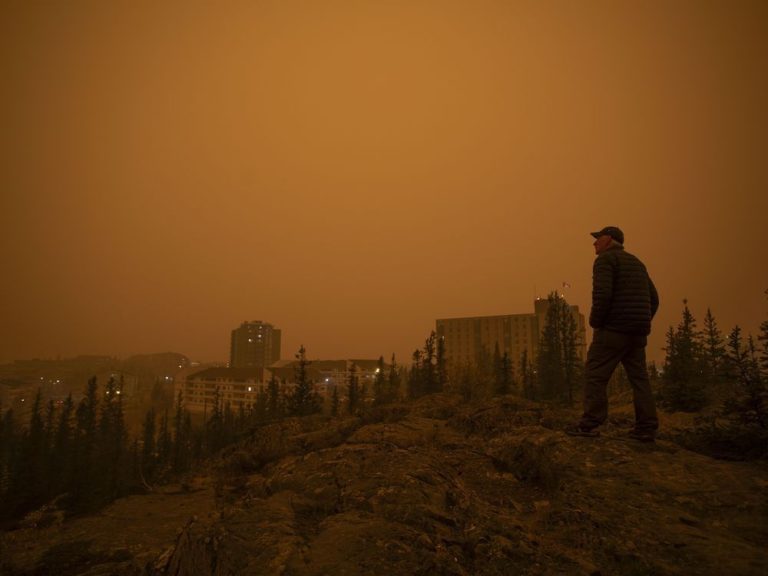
[579,330,659,432]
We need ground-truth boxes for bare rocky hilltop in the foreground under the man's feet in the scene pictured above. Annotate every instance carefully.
[0,395,768,576]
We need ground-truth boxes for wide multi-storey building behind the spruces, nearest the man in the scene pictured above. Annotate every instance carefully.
[436,298,586,371]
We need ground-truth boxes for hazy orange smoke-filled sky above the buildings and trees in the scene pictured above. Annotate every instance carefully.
[0,0,768,362]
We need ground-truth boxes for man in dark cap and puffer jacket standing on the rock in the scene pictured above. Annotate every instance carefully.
[566,226,659,442]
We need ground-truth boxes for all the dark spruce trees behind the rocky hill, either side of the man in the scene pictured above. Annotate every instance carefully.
[0,292,768,522]
